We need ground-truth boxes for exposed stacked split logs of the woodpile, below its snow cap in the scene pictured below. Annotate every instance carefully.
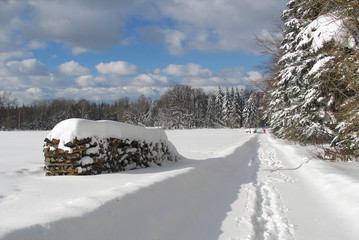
[43,137,178,176]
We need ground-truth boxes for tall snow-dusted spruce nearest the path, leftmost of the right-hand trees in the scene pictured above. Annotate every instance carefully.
[268,0,342,143]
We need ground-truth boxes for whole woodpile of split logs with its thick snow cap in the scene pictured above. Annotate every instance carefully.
[44,119,179,176]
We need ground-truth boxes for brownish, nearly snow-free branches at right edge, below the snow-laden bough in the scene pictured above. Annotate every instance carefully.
[316,41,359,161]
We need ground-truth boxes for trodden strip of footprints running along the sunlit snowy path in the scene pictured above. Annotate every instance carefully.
[235,136,295,240]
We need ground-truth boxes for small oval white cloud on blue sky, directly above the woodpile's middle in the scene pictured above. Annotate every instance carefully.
[96,61,138,75]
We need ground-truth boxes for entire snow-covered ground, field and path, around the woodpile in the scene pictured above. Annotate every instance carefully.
[0,129,359,240]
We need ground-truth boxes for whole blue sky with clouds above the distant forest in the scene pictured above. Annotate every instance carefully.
[0,0,287,104]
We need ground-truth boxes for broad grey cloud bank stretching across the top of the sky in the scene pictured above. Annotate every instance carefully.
[0,0,287,55]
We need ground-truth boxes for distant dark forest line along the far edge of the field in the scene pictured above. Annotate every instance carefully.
[0,85,264,130]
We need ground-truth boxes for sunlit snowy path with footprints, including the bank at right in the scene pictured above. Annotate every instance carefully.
[232,135,359,240]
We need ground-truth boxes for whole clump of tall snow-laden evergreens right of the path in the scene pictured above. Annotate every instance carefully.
[267,0,359,159]
